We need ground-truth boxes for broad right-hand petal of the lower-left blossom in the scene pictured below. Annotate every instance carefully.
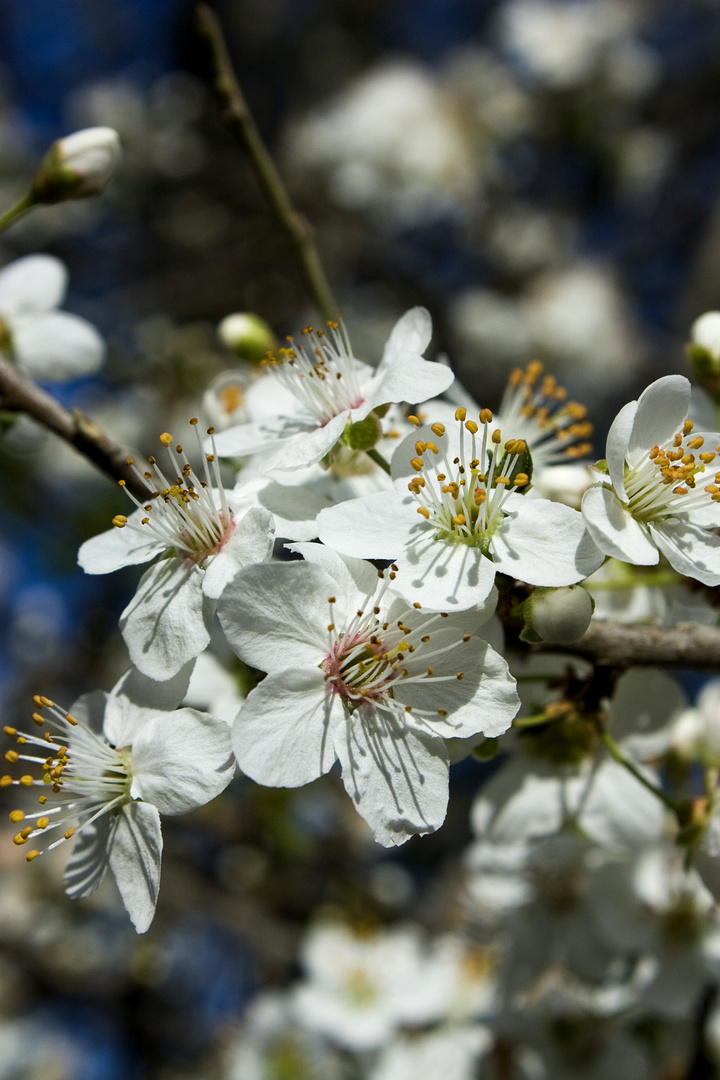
[131,708,235,814]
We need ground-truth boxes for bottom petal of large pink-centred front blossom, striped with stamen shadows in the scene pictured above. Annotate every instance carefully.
[335,705,449,848]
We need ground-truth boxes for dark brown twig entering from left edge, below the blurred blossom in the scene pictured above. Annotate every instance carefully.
[0,355,150,499]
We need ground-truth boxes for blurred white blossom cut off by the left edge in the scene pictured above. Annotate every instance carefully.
[0,255,105,382]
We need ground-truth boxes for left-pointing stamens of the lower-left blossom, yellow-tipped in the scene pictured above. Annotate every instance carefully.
[0,696,131,862]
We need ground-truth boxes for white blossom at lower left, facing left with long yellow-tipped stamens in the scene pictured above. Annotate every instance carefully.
[0,667,235,933]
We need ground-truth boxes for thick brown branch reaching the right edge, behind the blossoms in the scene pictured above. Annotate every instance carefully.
[533,620,720,669]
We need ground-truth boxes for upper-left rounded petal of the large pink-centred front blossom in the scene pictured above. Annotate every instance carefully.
[218,563,335,672]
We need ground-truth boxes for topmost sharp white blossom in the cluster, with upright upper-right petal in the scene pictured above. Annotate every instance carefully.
[211,308,452,472]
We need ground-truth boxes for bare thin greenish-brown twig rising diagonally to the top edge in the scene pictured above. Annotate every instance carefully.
[196,3,338,320]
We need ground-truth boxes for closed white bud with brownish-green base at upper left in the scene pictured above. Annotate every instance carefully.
[31,127,122,203]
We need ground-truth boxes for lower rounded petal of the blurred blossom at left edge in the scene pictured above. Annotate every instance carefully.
[13,311,105,382]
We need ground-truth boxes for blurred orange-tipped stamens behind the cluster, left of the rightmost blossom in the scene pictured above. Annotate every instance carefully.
[500,360,593,468]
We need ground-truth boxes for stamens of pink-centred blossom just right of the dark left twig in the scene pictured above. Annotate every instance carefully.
[112,419,235,564]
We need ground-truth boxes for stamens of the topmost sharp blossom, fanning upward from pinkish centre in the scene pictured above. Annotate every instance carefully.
[260,320,363,423]
